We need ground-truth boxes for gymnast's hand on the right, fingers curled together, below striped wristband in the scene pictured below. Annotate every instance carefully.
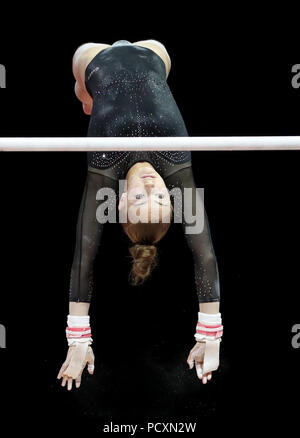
[187,340,220,384]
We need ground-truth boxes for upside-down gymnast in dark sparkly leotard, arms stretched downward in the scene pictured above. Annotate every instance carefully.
[57,40,222,390]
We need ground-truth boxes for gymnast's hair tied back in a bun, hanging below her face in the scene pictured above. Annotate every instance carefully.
[123,208,172,286]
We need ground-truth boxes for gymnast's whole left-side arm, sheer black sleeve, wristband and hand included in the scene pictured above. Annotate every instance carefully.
[57,171,117,390]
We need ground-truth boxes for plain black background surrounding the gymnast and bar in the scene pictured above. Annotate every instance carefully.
[0,3,300,433]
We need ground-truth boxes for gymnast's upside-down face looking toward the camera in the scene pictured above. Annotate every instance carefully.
[119,163,171,223]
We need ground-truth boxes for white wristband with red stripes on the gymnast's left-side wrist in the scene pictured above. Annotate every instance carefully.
[66,315,93,346]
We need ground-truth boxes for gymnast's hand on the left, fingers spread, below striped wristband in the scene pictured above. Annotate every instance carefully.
[57,344,95,391]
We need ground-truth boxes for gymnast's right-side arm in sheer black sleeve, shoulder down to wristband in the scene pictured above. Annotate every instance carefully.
[166,167,220,313]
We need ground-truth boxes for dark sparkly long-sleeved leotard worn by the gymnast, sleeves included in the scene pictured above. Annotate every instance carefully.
[69,41,219,302]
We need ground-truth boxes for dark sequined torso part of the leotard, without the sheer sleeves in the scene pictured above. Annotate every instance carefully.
[86,40,191,179]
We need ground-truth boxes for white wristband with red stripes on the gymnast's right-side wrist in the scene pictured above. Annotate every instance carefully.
[195,312,223,342]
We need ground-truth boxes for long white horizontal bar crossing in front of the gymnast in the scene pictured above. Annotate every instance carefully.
[0,136,300,152]
